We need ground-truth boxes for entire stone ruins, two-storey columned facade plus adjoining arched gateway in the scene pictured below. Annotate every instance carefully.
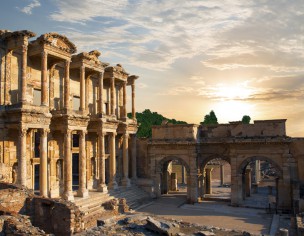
[0,30,304,217]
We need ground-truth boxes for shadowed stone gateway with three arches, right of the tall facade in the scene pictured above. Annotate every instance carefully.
[147,120,304,209]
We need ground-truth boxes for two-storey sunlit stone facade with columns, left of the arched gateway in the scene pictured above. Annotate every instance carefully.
[0,30,137,200]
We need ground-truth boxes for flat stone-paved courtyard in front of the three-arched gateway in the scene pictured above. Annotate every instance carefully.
[138,193,272,235]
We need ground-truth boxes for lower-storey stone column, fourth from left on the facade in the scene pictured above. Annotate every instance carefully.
[77,130,89,197]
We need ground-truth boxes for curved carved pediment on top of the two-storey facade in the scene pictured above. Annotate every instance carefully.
[37,33,77,54]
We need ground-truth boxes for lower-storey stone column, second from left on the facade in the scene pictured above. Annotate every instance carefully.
[39,129,49,197]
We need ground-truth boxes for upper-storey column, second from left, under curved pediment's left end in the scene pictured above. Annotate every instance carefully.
[41,51,49,106]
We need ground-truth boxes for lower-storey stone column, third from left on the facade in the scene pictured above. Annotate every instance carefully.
[63,130,74,201]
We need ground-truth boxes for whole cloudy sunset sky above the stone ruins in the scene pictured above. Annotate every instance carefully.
[0,0,304,137]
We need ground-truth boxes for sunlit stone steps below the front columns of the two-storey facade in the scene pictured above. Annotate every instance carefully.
[75,191,113,229]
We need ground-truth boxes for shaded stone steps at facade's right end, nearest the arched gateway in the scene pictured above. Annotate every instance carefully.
[109,185,152,210]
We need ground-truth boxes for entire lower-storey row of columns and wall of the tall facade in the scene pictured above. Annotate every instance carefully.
[15,128,136,200]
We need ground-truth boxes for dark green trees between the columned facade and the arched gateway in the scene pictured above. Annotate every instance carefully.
[128,109,187,138]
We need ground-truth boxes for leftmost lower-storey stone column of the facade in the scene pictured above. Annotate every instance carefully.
[18,128,27,186]
